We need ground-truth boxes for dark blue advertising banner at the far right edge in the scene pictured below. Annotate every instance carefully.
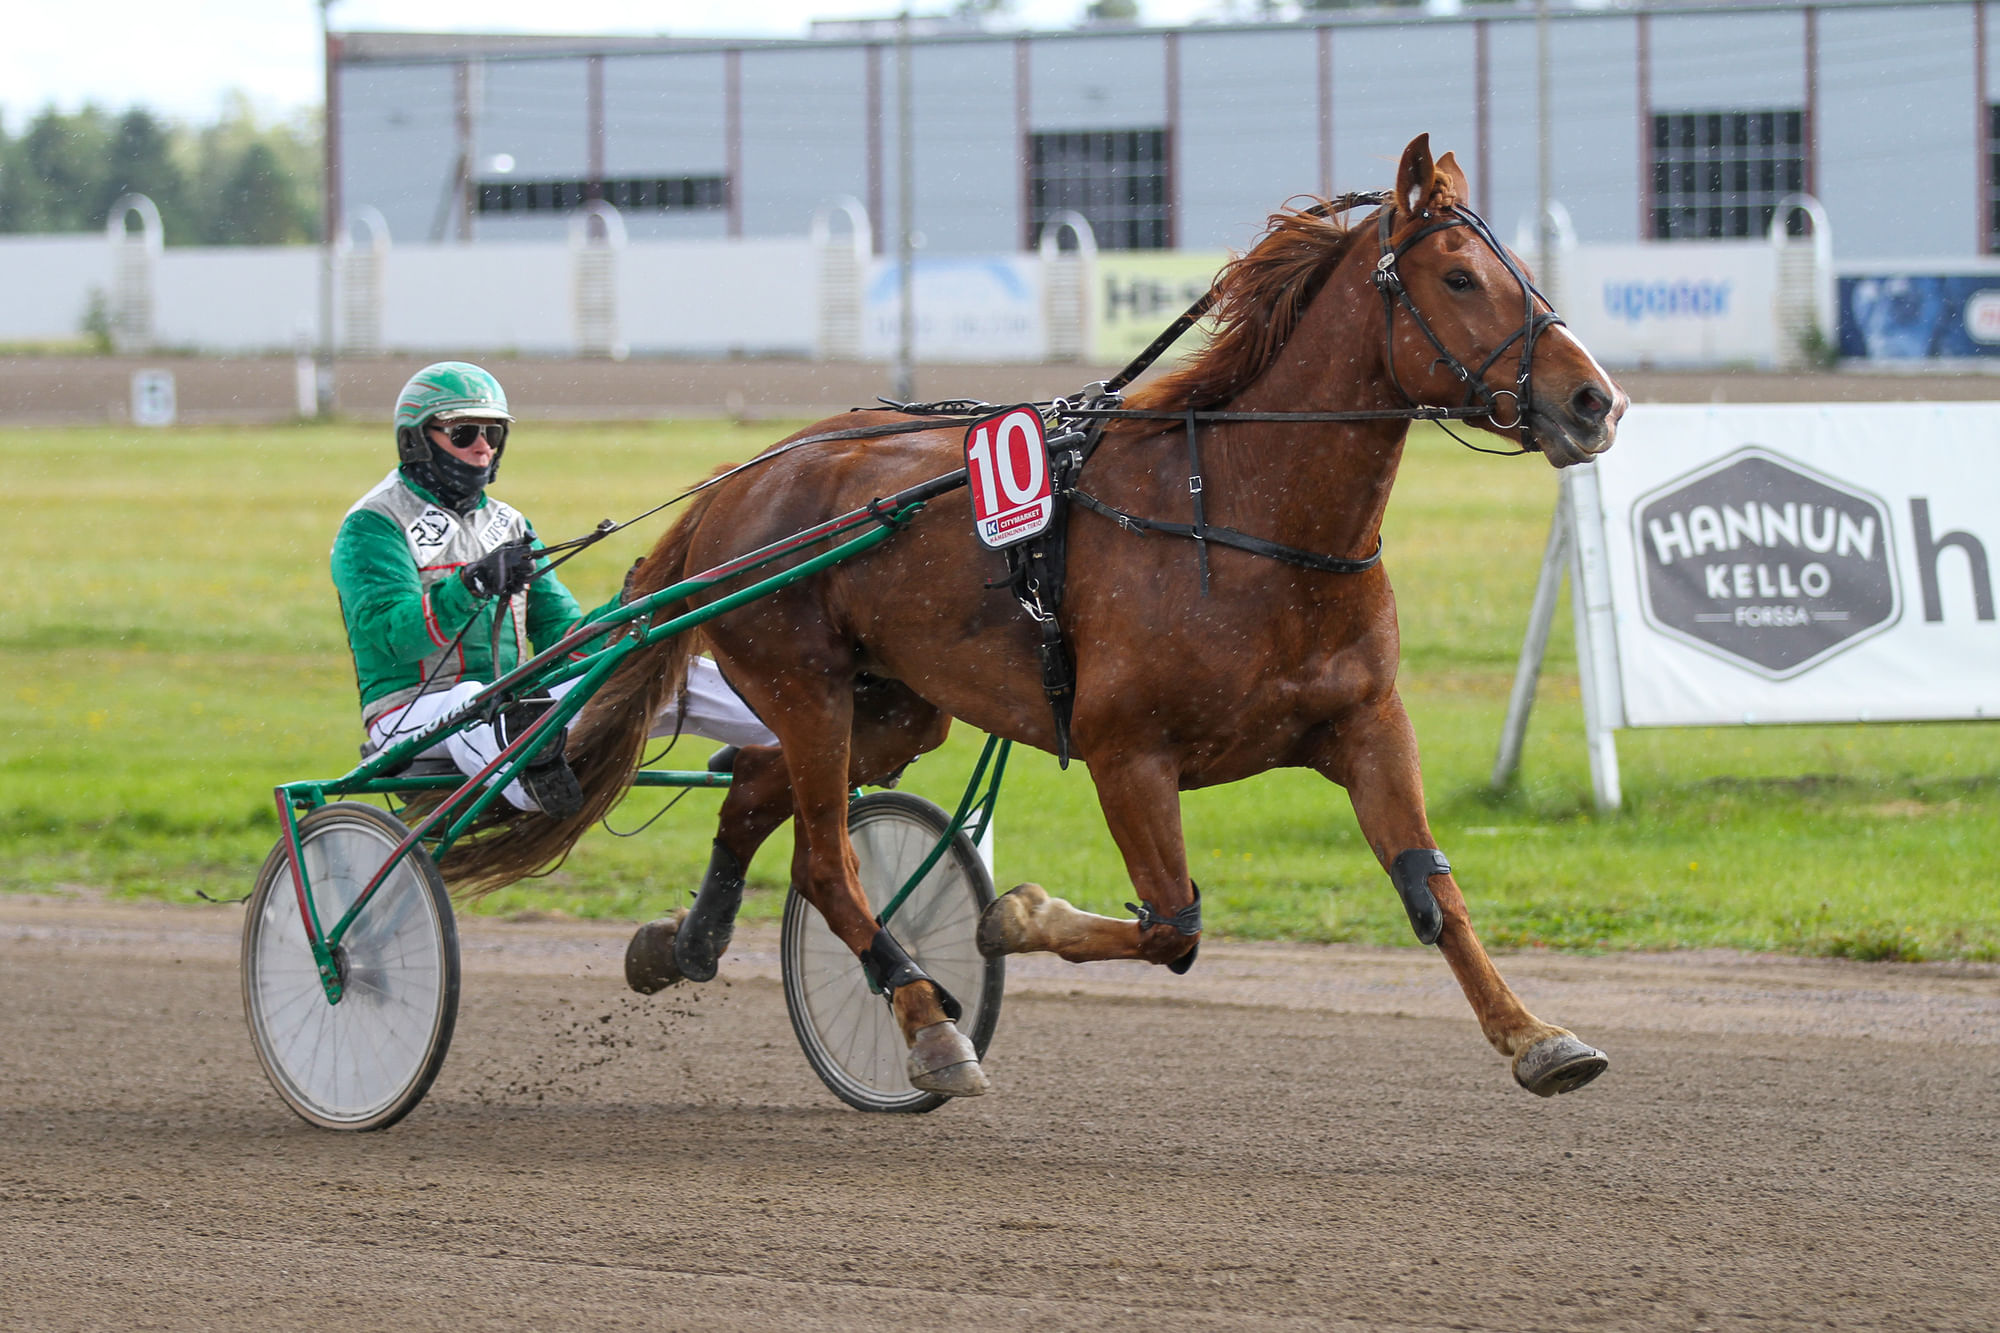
[1840,272,2000,360]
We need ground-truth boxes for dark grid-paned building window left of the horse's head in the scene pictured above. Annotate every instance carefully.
[1028,130,1172,250]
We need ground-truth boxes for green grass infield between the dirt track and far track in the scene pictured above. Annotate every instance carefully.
[0,420,2000,961]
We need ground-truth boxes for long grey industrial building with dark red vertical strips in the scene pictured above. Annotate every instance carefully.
[330,2,2000,264]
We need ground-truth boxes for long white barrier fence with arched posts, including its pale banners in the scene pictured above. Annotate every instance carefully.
[0,196,1836,366]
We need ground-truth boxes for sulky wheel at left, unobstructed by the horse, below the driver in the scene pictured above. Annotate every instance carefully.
[242,801,458,1129]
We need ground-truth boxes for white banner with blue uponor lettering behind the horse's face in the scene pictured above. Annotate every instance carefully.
[1562,240,1778,366]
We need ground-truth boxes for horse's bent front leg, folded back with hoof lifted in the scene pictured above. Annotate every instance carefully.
[978,755,1202,973]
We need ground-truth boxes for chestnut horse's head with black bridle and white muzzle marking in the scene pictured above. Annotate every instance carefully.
[1384,134,1628,468]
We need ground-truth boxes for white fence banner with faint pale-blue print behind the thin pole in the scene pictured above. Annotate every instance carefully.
[862,254,1048,362]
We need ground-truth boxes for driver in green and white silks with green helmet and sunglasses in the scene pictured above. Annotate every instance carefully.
[334,360,778,819]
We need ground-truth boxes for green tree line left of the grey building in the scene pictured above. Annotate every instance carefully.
[0,94,320,246]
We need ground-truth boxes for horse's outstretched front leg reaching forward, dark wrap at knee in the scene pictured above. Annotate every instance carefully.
[1314,691,1606,1097]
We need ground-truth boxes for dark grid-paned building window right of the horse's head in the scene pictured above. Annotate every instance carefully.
[1652,110,1806,240]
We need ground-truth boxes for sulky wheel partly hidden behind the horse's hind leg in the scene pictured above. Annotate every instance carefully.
[778,793,1006,1113]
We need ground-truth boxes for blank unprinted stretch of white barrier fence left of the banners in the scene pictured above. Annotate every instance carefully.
[0,211,818,356]
